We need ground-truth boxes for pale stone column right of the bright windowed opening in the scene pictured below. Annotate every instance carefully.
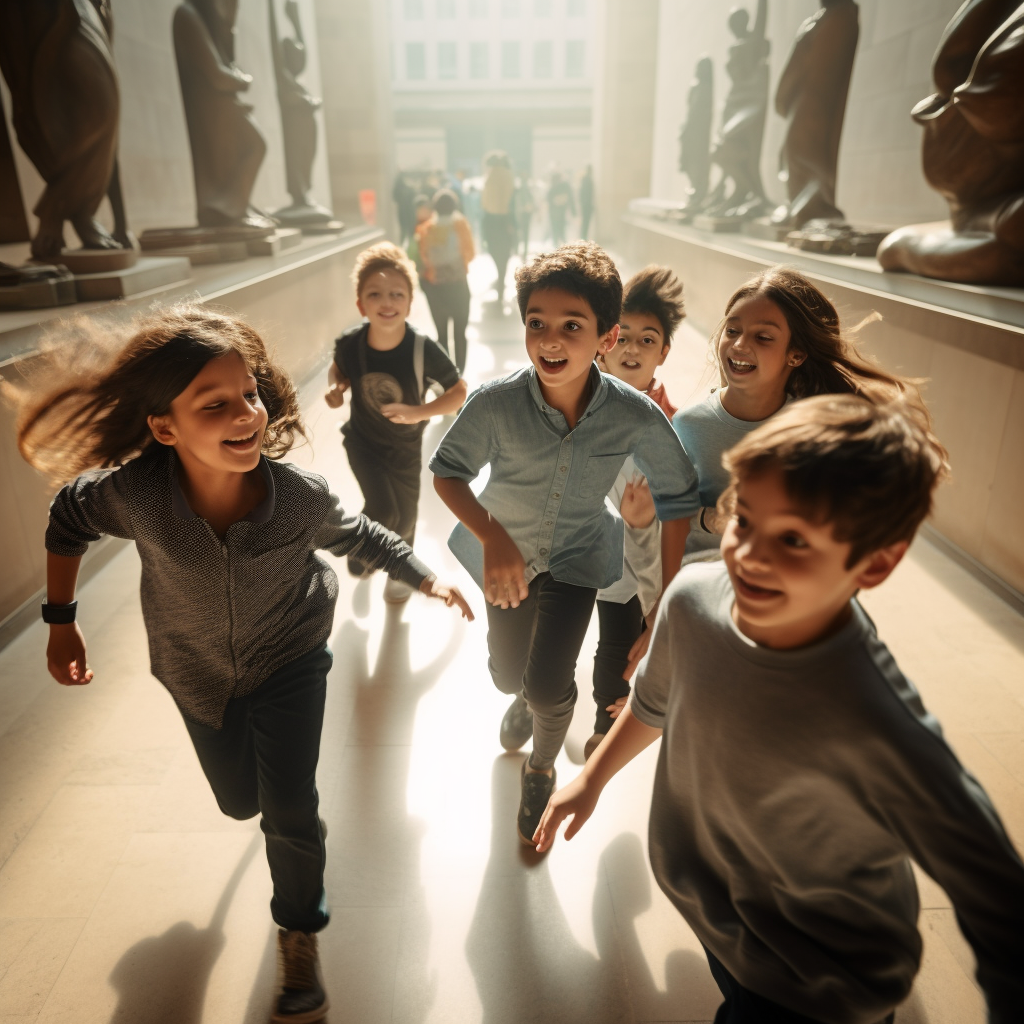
[593,0,658,245]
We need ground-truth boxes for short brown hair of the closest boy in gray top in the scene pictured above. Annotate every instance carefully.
[719,394,949,568]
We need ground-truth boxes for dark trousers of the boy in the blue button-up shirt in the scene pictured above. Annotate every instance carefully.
[487,572,597,771]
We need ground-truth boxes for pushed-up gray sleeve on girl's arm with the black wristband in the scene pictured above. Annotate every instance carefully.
[46,469,135,558]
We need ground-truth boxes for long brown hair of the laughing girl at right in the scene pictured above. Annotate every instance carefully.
[712,266,928,420]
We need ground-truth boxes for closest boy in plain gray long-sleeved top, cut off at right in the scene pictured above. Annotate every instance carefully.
[535,395,1024,1024]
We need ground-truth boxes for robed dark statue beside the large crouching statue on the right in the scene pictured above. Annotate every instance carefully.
[771,0,860,227]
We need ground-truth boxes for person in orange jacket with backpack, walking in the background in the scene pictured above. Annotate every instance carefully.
[416,188,476,377]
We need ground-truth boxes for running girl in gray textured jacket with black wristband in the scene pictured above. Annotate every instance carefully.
[5,306,472,1024]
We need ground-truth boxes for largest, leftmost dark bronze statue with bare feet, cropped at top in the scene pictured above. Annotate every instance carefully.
[0,0,134,260]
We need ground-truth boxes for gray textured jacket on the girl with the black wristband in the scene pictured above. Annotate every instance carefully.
[46,445,431,728]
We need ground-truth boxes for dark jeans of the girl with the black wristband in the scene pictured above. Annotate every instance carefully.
[185,647,332,932]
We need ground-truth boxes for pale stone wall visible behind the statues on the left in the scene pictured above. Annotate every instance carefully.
[4,0,331,245]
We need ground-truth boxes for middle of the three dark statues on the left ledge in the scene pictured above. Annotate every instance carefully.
[174,0,274,234]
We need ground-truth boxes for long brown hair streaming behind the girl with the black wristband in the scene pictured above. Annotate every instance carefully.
[4,305,306,481]
